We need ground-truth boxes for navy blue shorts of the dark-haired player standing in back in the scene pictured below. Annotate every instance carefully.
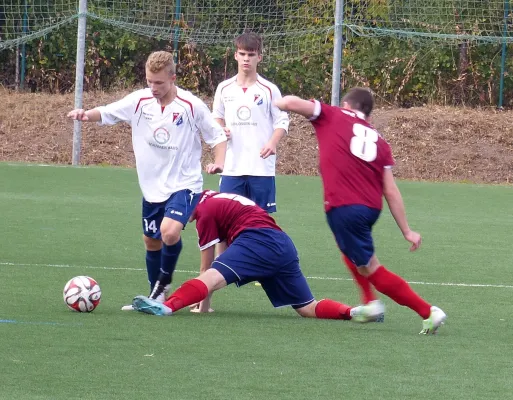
[219,175,276,214]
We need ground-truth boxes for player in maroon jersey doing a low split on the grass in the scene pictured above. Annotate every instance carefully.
[132,191,359,320]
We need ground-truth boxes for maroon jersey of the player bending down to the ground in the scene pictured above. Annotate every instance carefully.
[194,190,281,250]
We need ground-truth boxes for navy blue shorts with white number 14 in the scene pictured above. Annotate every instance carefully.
[142,189,201,239]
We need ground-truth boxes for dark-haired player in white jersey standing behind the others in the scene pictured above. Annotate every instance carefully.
[212,32,289,213]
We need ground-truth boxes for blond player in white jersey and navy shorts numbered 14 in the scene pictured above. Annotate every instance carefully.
[68,51,226,310]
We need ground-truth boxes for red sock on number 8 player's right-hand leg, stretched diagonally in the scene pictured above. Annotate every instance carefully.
[368,265,431,319]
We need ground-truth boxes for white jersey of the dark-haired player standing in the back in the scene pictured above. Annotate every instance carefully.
[212,75,289,176]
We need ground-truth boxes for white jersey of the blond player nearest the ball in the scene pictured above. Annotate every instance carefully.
[97,88,226,203]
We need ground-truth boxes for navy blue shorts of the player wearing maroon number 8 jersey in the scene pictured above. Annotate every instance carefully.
[326,205,381,267]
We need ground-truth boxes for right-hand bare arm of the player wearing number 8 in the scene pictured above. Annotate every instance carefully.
[383,168,422,251]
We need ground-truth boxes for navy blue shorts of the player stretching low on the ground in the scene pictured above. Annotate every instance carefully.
[212,228,314,308]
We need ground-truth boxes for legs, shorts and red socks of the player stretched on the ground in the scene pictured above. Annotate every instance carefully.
[133,229,352,319]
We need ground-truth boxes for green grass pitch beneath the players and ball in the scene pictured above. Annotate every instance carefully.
[0,164,513,400]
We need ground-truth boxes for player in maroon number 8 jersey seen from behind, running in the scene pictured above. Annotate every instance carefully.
[275,88,447,334]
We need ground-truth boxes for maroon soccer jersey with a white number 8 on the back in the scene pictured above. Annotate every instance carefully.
[311,101,394,211]
